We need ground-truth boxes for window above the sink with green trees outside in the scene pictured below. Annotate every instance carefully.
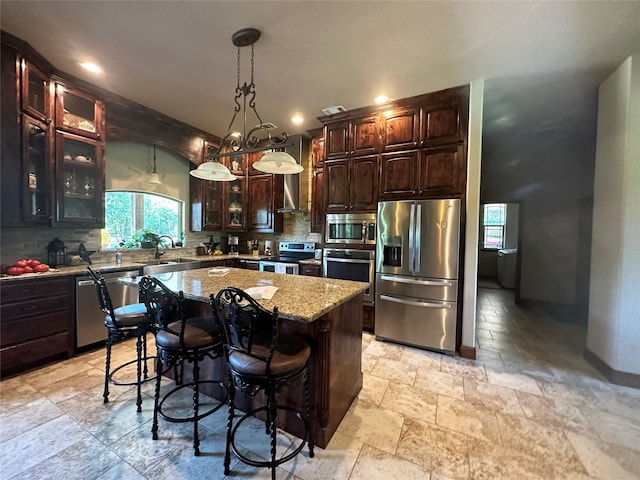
[102,191,184,248]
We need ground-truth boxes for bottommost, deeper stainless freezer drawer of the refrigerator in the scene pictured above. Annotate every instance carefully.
[375,292,457,355]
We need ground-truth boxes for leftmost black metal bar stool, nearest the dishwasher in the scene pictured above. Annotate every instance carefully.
[87,267,155,412]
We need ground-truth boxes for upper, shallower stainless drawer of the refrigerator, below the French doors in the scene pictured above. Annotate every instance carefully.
[376,273,458,302]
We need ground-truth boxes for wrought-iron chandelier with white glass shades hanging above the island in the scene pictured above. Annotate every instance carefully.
[189,28,303,181]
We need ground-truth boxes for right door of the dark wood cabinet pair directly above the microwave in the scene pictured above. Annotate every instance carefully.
[349,155,378,211]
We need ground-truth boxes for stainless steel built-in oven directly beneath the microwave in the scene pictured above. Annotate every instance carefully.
[322,248,376,305]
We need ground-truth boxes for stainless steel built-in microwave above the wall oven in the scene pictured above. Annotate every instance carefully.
[324,213,376,245]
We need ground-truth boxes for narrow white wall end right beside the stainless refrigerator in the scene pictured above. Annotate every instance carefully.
[462,80,484,348]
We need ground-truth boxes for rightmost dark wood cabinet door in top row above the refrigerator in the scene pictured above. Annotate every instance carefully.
[421,98,466,147]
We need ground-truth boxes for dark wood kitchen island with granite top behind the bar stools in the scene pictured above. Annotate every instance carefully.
[122,268,369,448]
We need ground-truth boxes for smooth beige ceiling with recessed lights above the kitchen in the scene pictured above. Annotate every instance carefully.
[0,0,640,152]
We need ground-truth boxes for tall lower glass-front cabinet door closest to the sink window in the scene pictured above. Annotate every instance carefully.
[56,132,104,226]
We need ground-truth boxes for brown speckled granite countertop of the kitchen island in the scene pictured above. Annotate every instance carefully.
[120,268,369,323]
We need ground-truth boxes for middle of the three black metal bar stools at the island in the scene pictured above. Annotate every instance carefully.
[139,276,227,456]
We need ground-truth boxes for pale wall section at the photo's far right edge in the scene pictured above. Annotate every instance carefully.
[587,55,640,374]
